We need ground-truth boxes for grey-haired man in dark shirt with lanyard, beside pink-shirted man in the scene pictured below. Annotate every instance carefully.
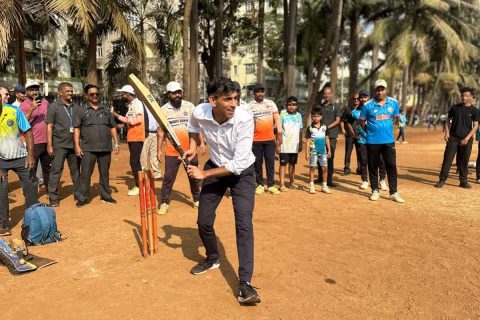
[45,82,80,207]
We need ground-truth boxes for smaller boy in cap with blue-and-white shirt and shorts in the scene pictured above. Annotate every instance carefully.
[305,109,332,194]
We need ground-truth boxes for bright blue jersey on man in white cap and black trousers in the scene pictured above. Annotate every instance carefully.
[360,97,400,144]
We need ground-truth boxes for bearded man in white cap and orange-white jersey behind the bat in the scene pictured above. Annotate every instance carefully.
[157,81,205,214]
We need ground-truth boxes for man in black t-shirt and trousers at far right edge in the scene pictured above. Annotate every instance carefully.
[435,88,479,189]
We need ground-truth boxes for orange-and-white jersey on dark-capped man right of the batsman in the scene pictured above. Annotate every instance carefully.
[248,99,278,141]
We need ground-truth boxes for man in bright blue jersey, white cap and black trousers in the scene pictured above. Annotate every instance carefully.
[359,79,405,203]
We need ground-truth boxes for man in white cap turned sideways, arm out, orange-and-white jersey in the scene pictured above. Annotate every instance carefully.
[112,84,145,196]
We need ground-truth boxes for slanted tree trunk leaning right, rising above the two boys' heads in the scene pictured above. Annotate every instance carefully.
[307,0,343,114]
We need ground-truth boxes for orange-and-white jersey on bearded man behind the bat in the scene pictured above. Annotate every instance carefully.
[162,100,195,157]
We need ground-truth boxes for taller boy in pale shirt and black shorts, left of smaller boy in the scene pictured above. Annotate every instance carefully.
[278,96,303,192]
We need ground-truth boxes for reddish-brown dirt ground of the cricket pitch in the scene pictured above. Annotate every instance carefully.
[0,128,480,319]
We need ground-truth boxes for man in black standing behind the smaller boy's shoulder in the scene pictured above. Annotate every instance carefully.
[317,86,342,187]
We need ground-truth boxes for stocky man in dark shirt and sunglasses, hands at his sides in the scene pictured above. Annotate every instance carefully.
[73,84,120,208]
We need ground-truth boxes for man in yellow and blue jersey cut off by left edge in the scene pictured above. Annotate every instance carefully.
[0,86,38,237]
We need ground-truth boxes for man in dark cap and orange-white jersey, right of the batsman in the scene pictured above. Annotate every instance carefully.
[249,83,282,195]
